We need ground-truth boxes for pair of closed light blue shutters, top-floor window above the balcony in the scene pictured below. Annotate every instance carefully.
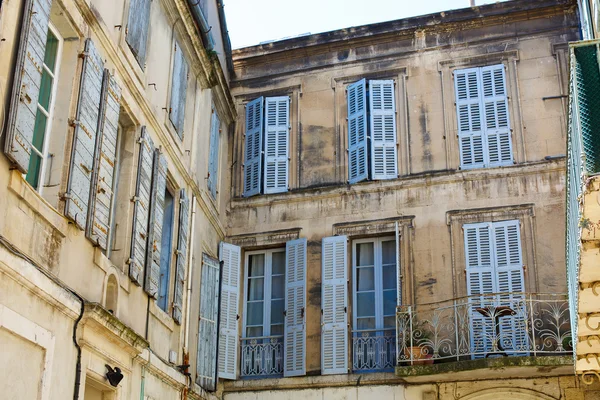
[454,64,513,169]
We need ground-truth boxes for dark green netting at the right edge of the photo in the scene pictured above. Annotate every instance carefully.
[575,45,600,174]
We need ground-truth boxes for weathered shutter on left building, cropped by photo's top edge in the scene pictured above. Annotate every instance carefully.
[125,0,152,65]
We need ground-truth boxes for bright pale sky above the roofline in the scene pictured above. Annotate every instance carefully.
[224,0,506,49]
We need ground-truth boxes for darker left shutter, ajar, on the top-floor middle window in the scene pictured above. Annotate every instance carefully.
[346,79,368,183]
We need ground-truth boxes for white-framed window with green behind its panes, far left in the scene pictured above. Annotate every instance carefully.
[25,25,62,193]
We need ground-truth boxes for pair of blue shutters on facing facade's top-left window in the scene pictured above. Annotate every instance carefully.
[244,96,290,197]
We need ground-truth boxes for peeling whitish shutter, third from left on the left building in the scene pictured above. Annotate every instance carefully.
[86,70,121,250]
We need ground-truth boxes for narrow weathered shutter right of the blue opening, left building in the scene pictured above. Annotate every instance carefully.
[173,189,190,324]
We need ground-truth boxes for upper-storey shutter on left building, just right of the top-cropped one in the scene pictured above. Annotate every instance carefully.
[169,42,188,140]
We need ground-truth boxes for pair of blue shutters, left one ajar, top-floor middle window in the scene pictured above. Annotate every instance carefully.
[346,79,398,183]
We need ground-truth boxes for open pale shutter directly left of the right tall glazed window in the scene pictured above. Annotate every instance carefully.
[321,236,348,375]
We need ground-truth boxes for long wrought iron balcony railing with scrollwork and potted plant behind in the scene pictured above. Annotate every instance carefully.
[396,293,573,366]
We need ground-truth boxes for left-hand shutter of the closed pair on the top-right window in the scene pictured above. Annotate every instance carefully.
[454,68,487,169]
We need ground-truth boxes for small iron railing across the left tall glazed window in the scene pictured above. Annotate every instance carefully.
[241,336,283,377]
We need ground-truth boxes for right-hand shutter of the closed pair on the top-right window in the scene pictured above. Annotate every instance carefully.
[481,64,513,167]
